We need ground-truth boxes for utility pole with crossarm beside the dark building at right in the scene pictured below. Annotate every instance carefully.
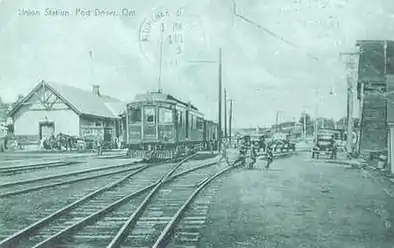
[340,52,360,153]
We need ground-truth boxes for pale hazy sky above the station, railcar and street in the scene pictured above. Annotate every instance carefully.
[0,0,394,127]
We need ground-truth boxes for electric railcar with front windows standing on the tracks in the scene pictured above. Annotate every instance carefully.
[126,92,218,158]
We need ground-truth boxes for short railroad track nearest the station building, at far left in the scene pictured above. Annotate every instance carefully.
[0,161,82,176]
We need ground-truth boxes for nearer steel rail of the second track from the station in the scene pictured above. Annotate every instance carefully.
[0,165,144,198]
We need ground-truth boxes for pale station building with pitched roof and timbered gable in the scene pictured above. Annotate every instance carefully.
[10,81,126,148]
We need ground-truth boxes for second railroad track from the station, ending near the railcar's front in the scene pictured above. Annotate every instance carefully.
[0,163,144,198]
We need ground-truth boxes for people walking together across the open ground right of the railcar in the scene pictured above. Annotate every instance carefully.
[226,135,274,169]
